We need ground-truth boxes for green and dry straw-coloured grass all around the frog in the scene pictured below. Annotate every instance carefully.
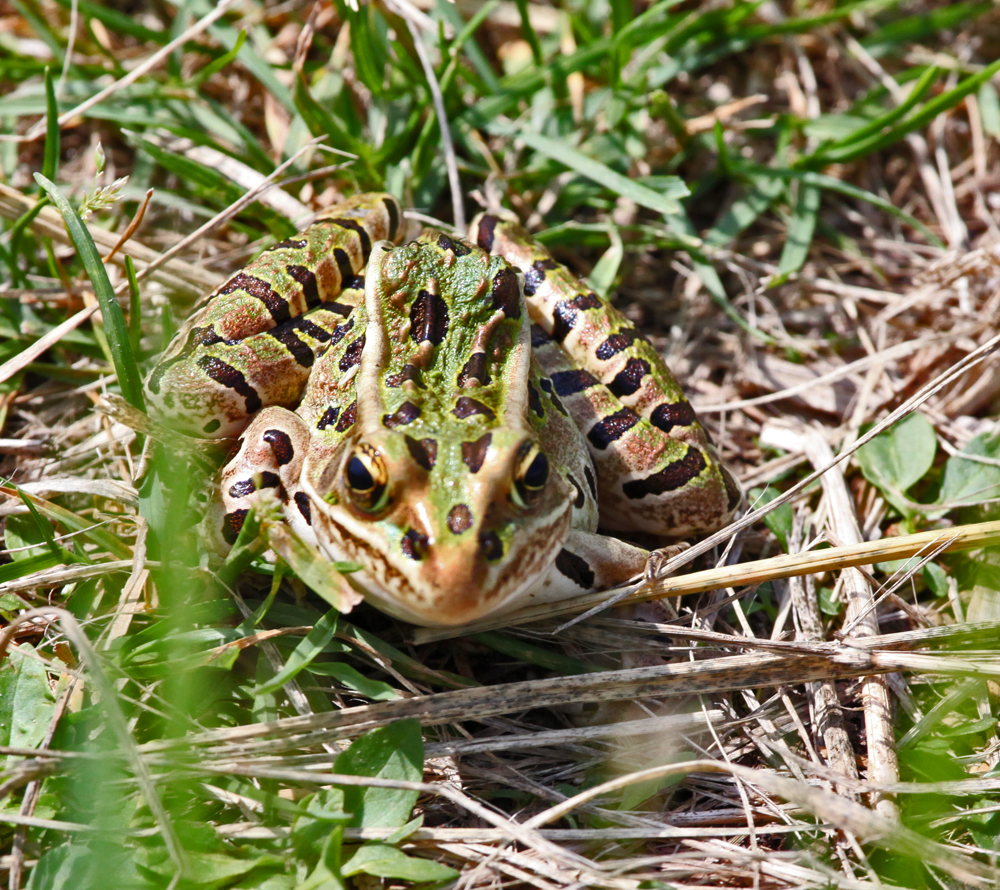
[0,0,1000,890]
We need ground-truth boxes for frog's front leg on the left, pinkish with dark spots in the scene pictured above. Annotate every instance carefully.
[209,407,314,546]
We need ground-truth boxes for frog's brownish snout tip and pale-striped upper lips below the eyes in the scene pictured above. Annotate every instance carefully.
[314,504,572,627]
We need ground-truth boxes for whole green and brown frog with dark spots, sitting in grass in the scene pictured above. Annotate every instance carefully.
[145,193,742,626]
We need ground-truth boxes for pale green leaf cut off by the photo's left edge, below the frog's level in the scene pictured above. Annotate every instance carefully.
[0,643,55,767]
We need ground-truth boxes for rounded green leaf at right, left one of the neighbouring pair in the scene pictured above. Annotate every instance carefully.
[856,414,937,515]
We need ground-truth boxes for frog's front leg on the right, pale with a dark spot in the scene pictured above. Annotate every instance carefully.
[524,530,649,605]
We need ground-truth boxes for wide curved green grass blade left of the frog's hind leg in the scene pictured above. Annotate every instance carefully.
[35,173,146,411]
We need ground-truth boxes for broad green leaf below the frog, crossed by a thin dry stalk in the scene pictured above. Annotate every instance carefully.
[333,720,424,828]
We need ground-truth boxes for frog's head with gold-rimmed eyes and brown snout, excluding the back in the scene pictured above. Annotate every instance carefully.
[303,427,574,625]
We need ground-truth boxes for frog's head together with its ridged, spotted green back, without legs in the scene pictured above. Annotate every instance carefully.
[302,234,574,625]
